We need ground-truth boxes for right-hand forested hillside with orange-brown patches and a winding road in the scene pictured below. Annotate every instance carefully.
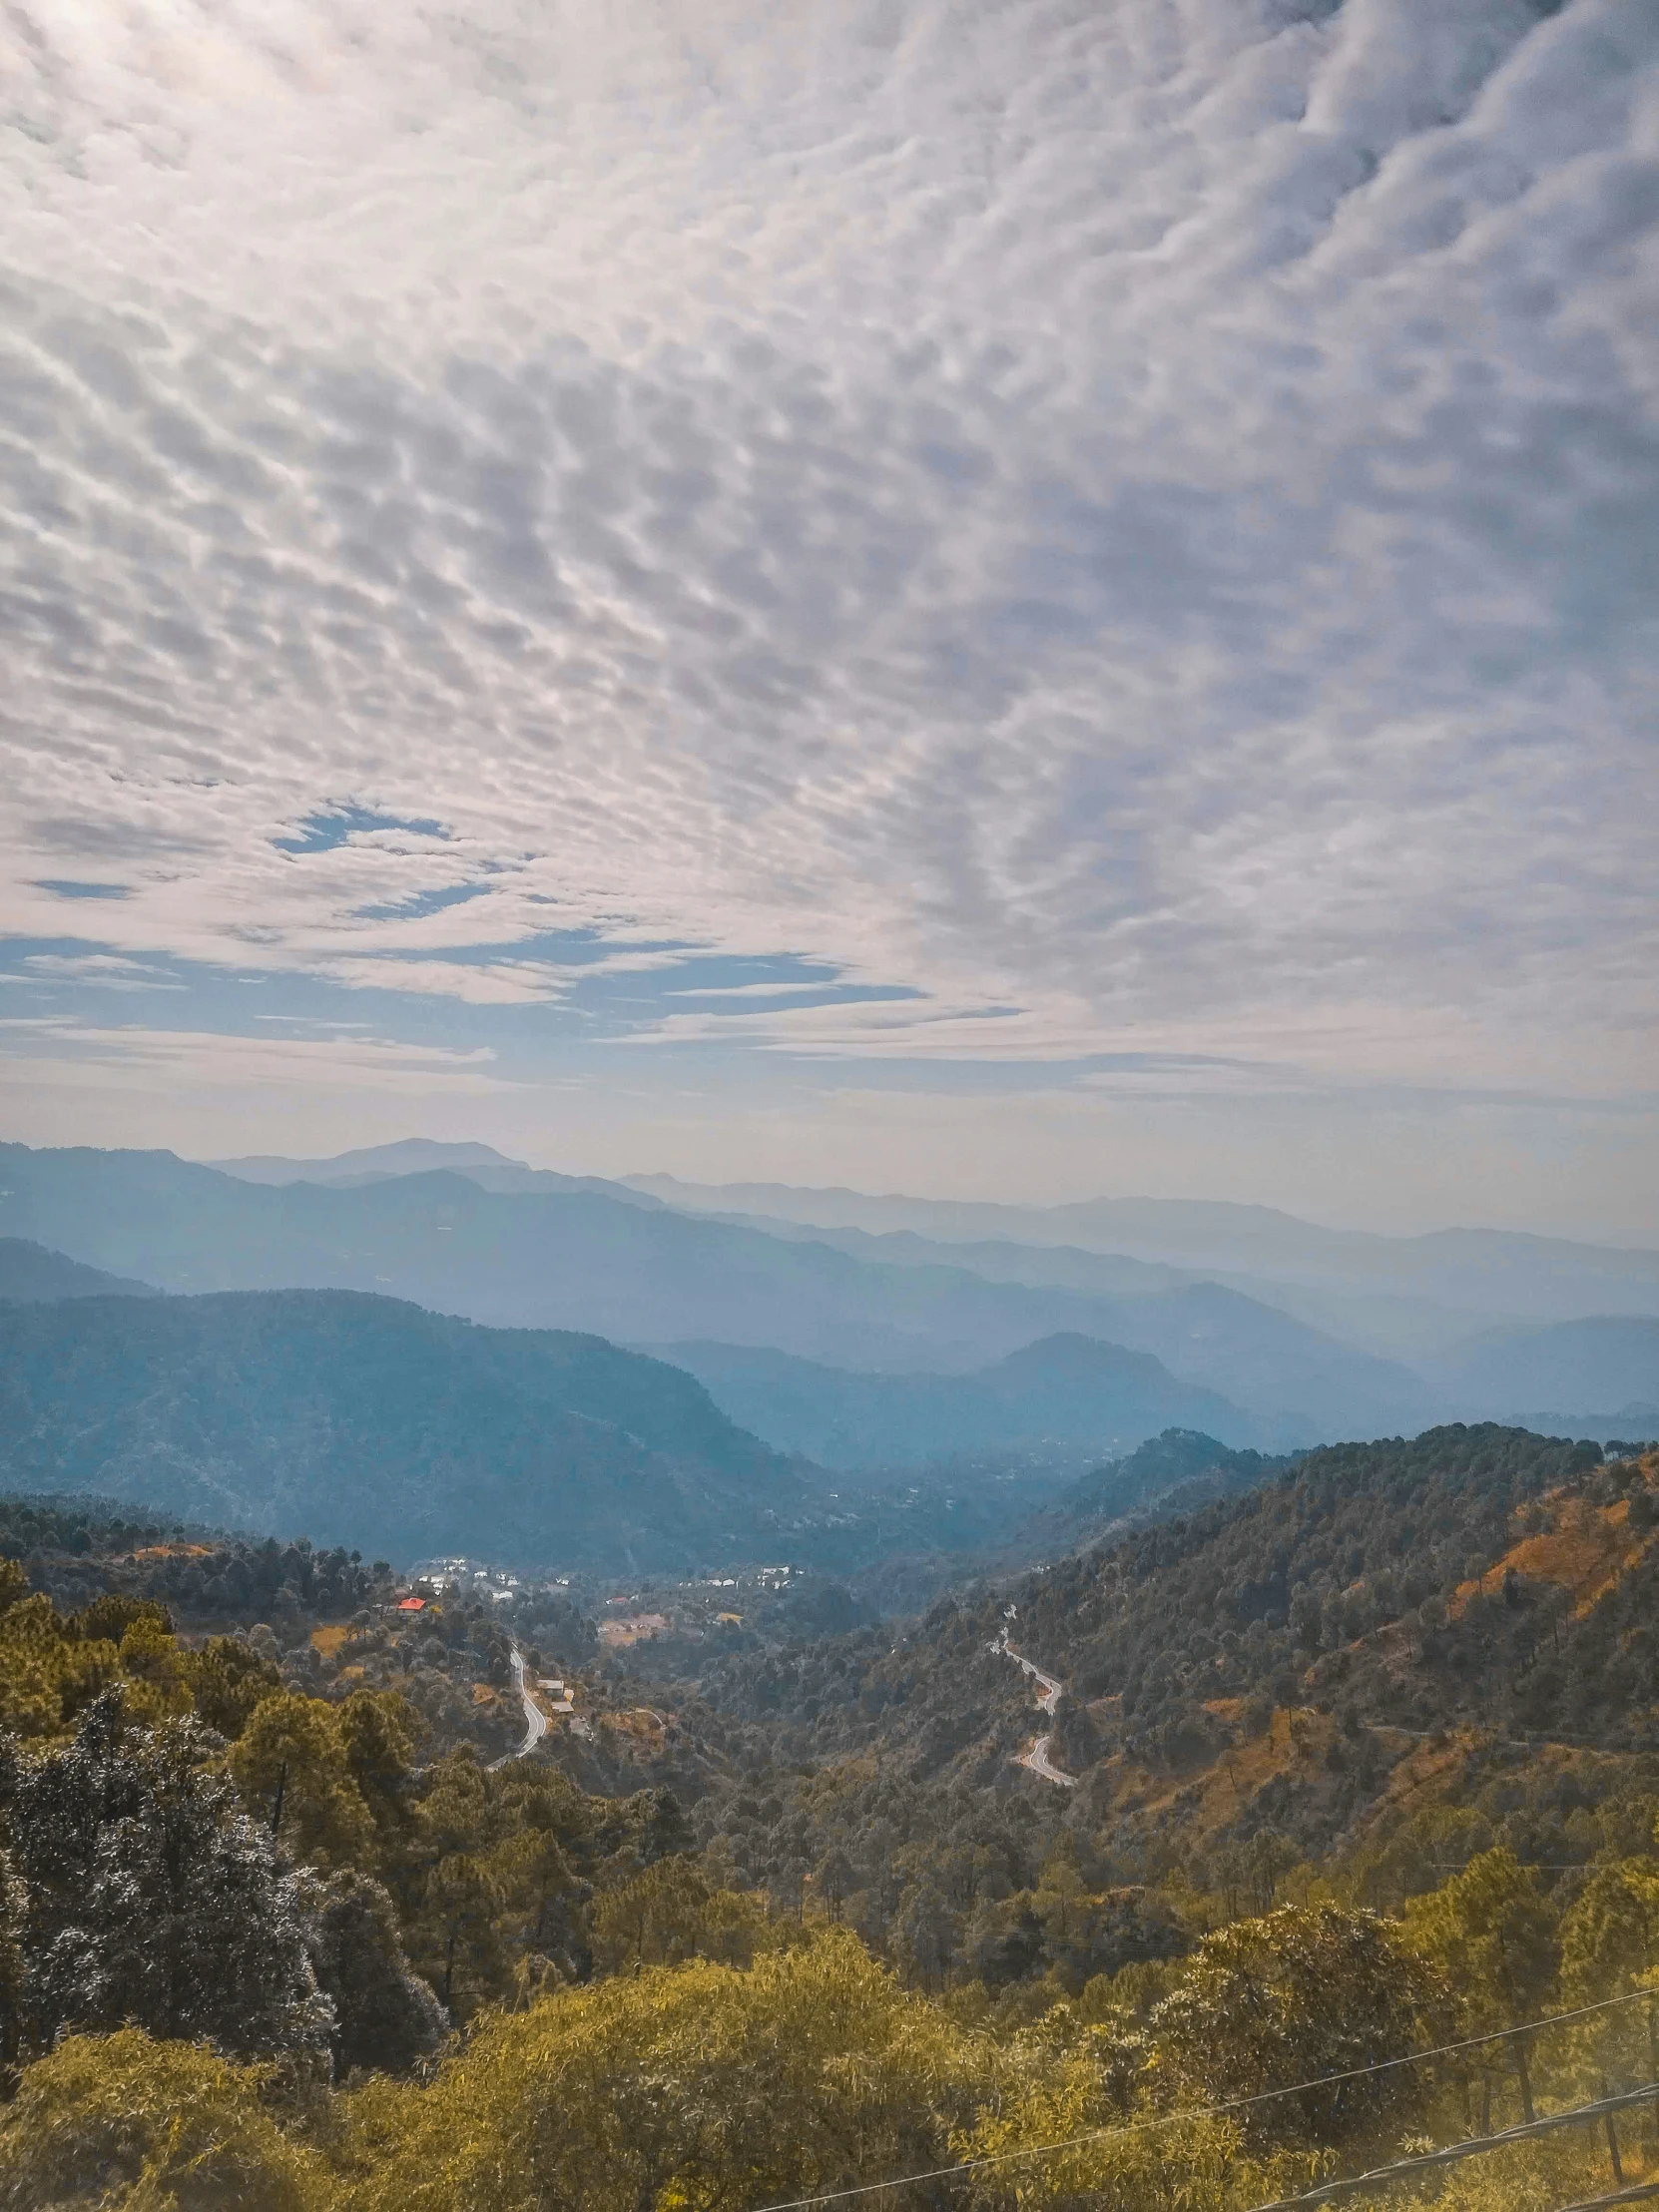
[592,1429,1659,1990]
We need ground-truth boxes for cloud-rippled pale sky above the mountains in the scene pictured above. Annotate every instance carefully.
[0,0,1659,1243]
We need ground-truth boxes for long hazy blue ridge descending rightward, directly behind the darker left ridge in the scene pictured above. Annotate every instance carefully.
[0,1146,1433,1446]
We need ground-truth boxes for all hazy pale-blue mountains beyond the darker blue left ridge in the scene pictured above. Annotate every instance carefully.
[0,1141,1659,1466]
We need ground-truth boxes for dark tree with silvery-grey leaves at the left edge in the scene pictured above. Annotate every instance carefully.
[0,1690,329,2052]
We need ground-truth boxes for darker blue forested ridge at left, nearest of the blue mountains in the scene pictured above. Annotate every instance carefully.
[0,1290,806,1573]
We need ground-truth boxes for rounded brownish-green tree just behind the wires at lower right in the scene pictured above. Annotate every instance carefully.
[1153,1905,1437,2143]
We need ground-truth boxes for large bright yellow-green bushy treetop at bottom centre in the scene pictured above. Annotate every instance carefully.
[340,1932,991,2212]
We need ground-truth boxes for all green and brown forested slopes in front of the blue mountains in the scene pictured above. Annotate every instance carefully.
[0,1431,1659,2212]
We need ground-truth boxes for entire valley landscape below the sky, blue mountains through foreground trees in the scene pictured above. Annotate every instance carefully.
[0,1148,1659,2212]
